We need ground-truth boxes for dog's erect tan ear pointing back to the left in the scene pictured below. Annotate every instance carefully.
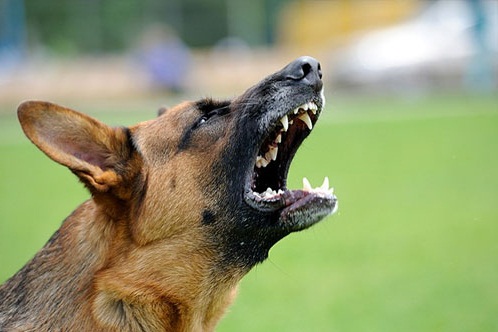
[17,101,131,192]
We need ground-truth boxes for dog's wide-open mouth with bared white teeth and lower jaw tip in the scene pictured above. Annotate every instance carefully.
[245,99,337,231]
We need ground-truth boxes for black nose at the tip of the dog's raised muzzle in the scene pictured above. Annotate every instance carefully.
[283,56,323,92]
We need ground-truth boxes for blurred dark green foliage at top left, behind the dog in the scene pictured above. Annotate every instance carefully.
[20,0,285,54]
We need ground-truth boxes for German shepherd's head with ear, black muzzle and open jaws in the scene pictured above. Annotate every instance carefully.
[18,57,337,270]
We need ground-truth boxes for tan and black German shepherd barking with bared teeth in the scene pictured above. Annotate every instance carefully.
[0,57,337,331]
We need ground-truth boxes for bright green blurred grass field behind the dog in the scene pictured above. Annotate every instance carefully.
[0,96,498,332]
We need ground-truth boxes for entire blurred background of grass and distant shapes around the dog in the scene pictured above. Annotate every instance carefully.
[0,0,498,331]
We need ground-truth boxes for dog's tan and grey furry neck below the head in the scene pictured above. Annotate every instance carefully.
[0,200,242,331]
